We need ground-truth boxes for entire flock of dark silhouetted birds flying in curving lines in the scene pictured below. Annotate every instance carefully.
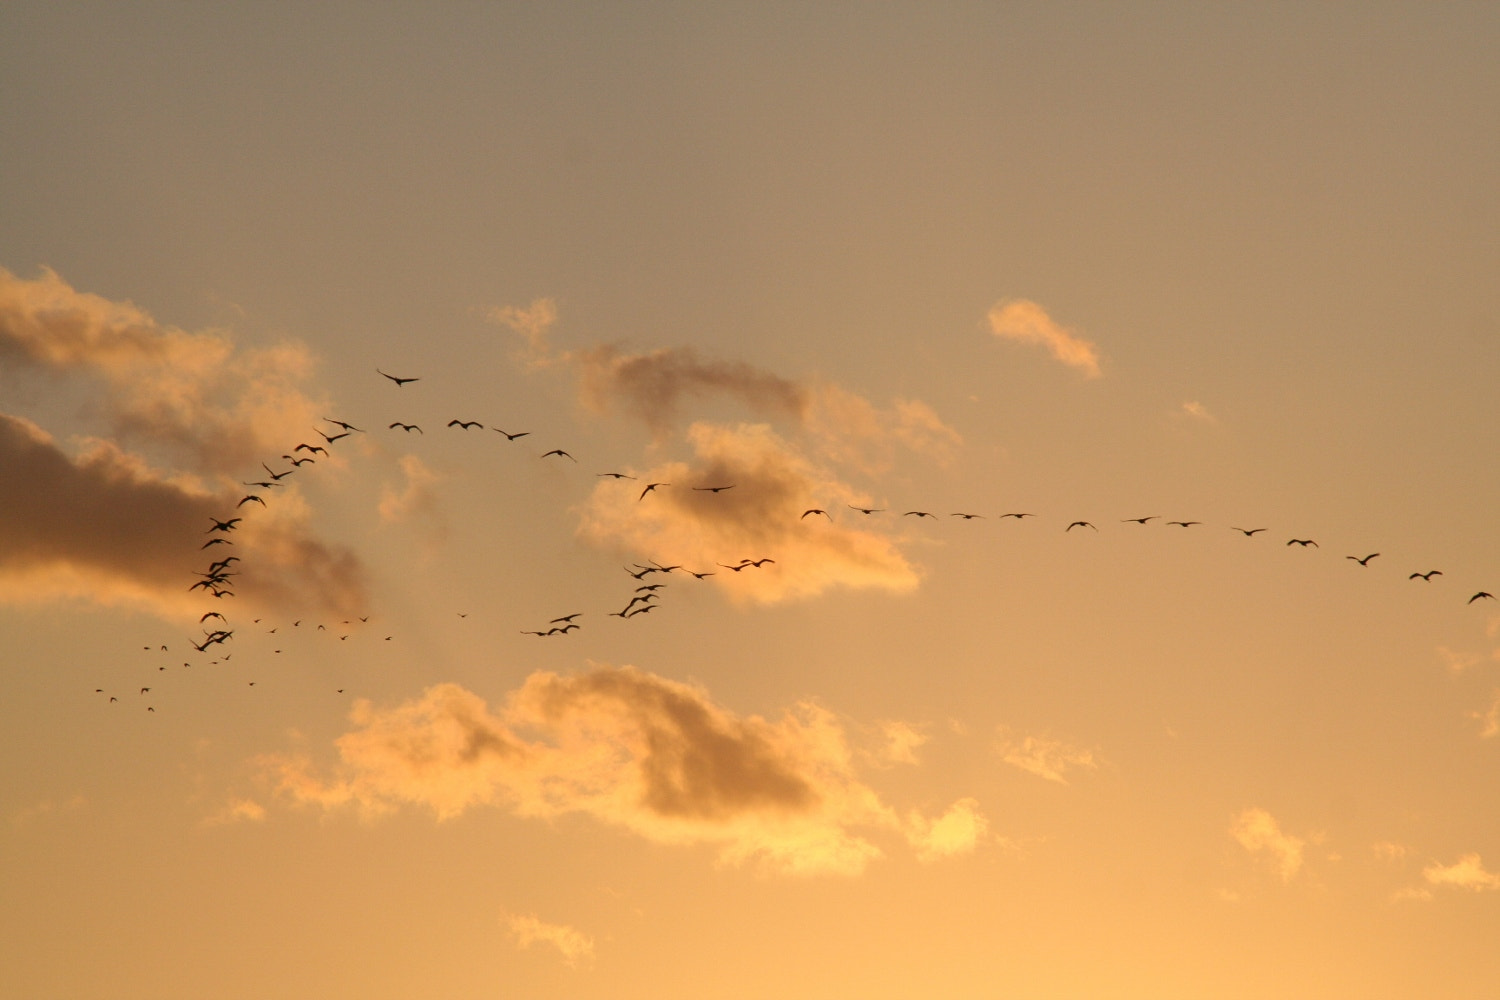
[95,369,1497,712]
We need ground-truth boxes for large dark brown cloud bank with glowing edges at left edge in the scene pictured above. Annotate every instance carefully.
[0,268,363,618]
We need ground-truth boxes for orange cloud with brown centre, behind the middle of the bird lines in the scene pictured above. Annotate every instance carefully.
[579,424,918,603]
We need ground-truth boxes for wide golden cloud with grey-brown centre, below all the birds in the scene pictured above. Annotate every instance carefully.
[263,667,983,874]
